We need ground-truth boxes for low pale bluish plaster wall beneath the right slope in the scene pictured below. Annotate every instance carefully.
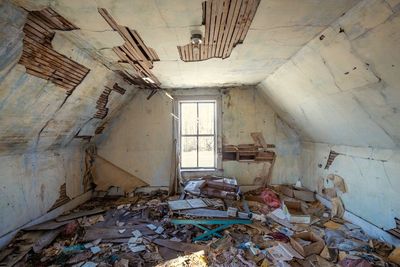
[301,142,400,230]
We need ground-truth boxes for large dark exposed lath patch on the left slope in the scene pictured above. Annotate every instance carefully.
[19,8,90,93]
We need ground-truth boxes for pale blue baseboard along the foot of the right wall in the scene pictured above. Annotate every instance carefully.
[316,194,400,247]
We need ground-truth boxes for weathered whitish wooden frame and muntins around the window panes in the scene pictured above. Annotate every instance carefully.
[174,95,222,172]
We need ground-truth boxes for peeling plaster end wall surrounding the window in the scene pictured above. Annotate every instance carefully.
[98,87,301,186]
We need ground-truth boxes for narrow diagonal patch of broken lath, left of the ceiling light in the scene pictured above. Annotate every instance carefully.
[98,8,160,89]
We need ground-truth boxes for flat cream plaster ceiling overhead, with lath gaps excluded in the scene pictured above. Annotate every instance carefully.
[14,0,358,88]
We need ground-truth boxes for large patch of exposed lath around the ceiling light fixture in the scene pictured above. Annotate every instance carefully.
[178,0,260,62]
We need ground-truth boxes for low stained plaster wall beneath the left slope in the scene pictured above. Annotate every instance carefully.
[0,146,84,237]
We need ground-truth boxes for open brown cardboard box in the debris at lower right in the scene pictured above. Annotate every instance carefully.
[290,232,325,257]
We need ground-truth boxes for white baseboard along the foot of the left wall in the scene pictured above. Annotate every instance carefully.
[0,191,92,249]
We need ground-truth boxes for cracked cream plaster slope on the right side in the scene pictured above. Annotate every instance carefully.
[259,0,400,149]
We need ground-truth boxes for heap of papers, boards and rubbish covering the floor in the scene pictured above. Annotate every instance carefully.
[0,177,400,267]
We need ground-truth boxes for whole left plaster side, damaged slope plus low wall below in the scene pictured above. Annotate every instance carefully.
[0,0,136,236]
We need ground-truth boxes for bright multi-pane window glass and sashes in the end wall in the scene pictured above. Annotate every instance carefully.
[179,100,217,169]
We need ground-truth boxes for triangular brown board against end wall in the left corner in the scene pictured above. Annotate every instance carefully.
[93,156,148,192]
